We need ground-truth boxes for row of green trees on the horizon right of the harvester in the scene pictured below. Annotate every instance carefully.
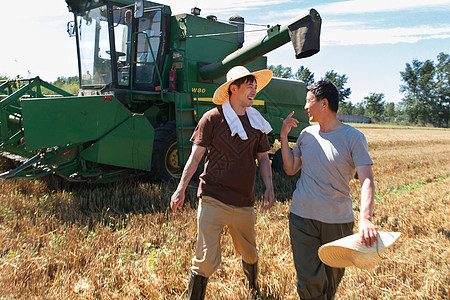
[269,52,450,127]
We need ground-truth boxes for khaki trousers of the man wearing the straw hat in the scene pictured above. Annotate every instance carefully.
[191,197,258,277]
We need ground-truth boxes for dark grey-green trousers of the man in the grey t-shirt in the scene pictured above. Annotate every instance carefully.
[289,213,354,299]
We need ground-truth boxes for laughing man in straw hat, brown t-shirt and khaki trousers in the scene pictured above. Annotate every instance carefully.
[170,66,275,299]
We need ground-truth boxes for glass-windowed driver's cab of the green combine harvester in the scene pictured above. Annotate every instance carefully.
[66,0,171,101]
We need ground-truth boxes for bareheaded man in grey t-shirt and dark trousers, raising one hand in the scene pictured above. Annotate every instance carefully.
[280,81,377,299]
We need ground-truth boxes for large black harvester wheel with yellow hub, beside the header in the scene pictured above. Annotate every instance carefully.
[151,122,183,181]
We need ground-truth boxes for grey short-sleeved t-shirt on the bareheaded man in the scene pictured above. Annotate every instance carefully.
[290,125,373,224]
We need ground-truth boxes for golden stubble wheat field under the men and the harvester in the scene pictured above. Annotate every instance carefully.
[0,125,450,299]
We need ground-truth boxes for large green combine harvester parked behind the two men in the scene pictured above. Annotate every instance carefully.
[0,0,321,182]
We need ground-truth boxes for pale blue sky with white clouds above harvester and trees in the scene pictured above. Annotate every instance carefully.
[0,0,450,103]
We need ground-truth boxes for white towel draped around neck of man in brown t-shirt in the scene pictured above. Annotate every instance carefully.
[222,99,272,140]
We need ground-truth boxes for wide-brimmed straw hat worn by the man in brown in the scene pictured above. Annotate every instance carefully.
[213,66,273,105]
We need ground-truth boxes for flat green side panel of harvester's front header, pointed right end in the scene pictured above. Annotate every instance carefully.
[21,96,132,150]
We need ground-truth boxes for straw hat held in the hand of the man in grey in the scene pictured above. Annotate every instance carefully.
[319,232,401,269]
